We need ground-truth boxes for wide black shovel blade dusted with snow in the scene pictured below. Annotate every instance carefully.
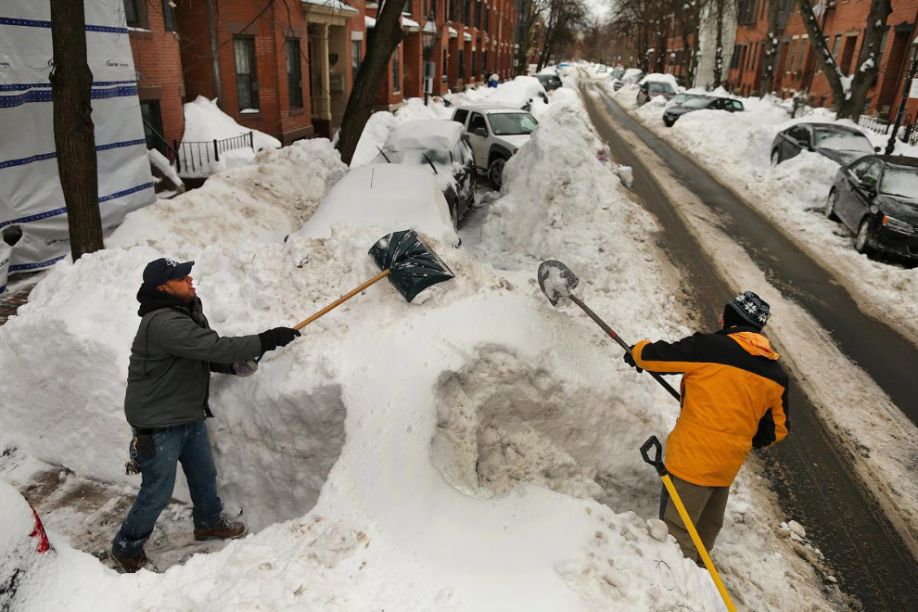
[370,230,454,302]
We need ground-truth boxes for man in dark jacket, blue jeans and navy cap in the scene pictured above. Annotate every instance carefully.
[112,259,300,572]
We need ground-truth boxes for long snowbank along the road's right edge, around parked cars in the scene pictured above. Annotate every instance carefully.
[613,77,918,339]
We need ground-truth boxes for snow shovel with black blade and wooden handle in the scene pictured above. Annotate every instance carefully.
[246,230,455,368]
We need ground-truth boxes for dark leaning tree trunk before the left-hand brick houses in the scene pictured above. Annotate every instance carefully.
[338,0,405,165]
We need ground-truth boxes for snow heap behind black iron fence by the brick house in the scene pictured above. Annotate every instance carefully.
[178,96,281,177]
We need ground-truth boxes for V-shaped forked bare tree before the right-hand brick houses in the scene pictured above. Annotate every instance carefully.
[797,0,892,121]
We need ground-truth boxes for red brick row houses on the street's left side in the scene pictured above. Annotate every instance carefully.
[122,0,516,158]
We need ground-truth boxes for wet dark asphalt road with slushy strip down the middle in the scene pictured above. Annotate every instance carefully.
[581,85,918,610]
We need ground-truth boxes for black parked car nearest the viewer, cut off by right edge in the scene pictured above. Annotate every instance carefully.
[825,155,918,262]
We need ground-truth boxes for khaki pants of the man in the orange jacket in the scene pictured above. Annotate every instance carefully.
[660,474,730,563]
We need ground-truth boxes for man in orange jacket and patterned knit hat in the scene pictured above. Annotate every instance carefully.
[624,291,790,562]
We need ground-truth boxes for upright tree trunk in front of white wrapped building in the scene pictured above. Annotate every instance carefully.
[50,0,105,261]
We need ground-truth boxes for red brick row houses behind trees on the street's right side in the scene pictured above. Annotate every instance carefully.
[670,0,918,121]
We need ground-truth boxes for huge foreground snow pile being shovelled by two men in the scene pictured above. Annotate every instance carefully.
[0,92,836,611]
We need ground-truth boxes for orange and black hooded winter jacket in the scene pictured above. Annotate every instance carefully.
[631,327,790,487]
